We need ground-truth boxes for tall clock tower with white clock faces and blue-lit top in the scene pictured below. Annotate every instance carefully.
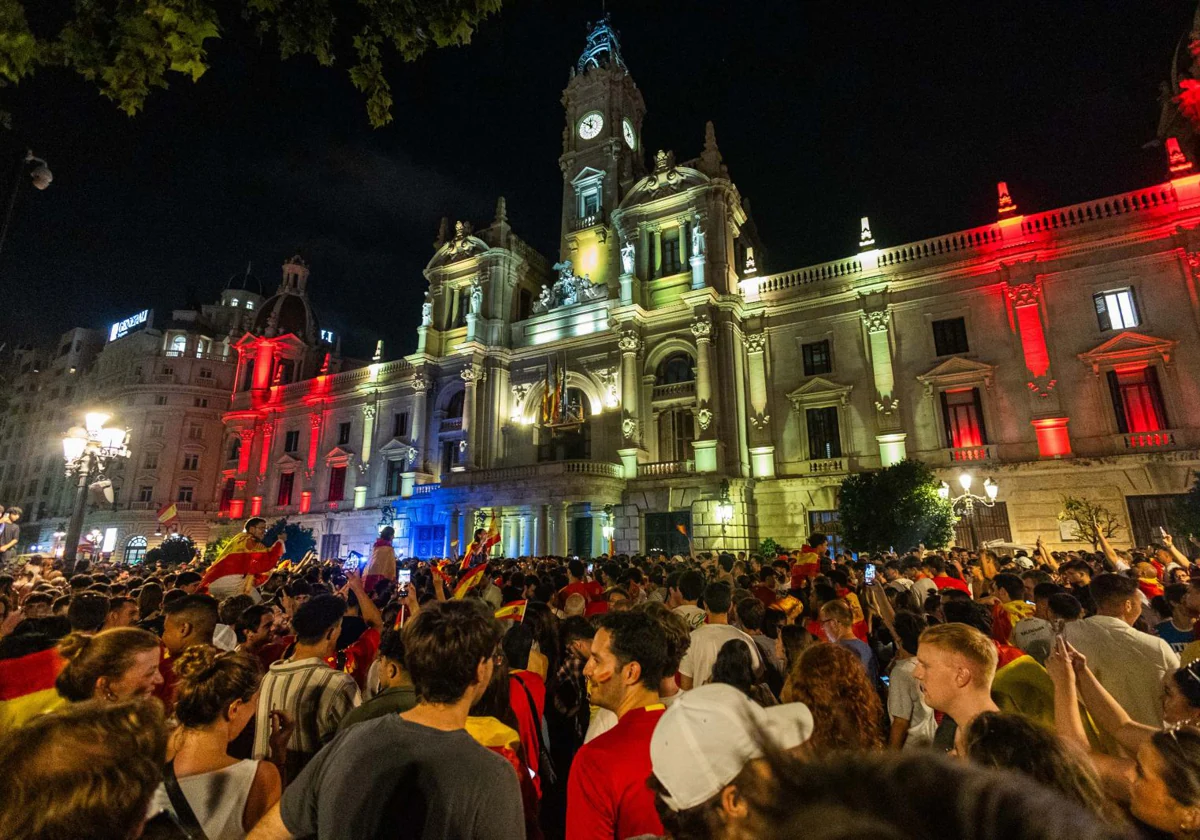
[558,14,646,290]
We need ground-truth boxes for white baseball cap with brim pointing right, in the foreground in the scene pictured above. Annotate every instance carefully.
[650,683,812,811]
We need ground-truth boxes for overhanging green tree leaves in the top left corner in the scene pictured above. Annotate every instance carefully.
[0,0,502,127]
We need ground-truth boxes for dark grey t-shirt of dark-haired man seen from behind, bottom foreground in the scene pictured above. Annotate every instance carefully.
[280,714,526,840]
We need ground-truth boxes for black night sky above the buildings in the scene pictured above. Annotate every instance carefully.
[0,0,1195,358]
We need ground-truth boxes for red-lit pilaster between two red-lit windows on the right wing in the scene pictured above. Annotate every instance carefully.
[1008,281,1070,458]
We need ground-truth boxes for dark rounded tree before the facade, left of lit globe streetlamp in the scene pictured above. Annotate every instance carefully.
[838,461,955,552]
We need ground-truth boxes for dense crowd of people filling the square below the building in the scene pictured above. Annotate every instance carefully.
[0,517,1200,840]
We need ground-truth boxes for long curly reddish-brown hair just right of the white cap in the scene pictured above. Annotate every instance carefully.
[782,642,883,755]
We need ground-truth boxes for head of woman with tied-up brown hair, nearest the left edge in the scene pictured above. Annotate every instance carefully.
[54,628,162,703]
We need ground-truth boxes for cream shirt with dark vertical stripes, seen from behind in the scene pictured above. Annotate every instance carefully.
[254,656,362,779]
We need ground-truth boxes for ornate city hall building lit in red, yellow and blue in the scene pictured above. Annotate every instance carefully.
[211,18,1200,557]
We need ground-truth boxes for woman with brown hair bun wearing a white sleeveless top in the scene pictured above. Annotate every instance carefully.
[158,644,292,840]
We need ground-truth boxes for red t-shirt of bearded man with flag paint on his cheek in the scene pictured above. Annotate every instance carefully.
[566,703,665,840]
